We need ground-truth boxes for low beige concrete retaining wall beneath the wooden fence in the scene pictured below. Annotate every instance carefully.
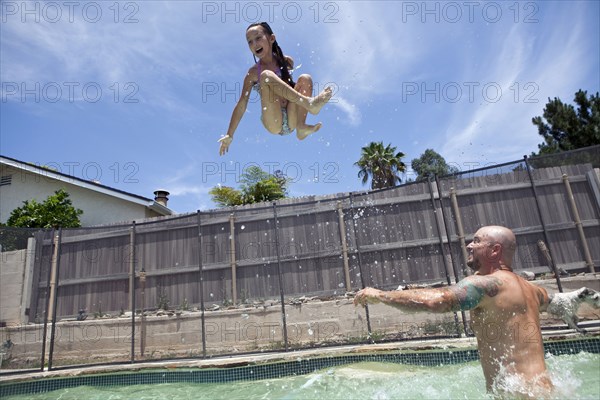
[0,274,600,368]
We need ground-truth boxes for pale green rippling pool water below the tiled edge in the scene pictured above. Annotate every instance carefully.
[9,352,600,400]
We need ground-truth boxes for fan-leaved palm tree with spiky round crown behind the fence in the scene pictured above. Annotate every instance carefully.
[354,142,406,189]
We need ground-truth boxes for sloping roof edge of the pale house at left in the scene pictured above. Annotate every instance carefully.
[0,155,173,215]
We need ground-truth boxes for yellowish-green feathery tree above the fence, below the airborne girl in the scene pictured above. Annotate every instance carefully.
[209,166,289,207]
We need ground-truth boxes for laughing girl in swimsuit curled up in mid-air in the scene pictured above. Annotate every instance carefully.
[219,22,332,155]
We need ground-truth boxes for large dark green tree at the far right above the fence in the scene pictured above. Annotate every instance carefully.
[531,89,600,156]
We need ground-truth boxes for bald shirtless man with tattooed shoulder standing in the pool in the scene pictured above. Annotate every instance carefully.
[354,226,552,398]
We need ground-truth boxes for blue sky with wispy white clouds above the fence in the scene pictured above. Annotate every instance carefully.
[0,0,600,212]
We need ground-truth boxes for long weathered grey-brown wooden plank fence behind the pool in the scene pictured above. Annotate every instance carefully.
[24,148,600,321]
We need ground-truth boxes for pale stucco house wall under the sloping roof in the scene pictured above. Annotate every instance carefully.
[0,165,158,226]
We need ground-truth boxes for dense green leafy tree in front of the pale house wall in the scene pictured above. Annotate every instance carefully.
[6,189,83,228]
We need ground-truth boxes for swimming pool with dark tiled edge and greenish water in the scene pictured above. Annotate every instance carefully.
[0,337,600,400]
